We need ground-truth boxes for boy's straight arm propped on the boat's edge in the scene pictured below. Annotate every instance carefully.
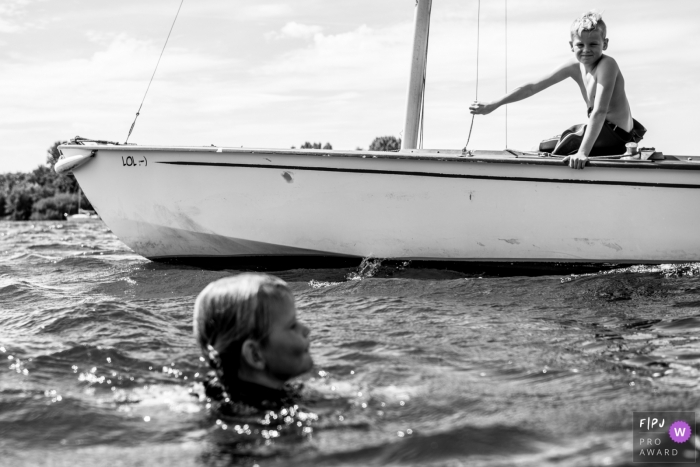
[564,57,620,169]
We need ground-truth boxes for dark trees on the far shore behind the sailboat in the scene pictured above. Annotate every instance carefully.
[0,136,401,220]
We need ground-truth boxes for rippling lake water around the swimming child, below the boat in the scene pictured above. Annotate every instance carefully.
[0,222,700,467]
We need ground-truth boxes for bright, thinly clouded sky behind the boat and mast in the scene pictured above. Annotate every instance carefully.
[0,0,700,173]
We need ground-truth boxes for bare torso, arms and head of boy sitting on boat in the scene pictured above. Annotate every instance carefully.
[469,11,641,169]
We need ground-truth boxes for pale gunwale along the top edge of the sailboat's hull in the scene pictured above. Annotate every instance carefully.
[59,144,700,170]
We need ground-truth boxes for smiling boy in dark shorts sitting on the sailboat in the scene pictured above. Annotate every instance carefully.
[469,11,646,169]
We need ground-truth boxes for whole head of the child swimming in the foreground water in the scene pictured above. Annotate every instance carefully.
[194,274,313,388]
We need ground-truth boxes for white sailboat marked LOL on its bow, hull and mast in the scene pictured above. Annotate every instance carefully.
[56,0,700,267]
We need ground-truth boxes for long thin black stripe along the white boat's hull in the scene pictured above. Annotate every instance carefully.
[158,161,700,189]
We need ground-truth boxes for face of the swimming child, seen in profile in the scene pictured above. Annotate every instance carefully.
[261,298,313,382]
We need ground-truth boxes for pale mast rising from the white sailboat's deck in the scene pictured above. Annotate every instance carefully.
[401,0,433,151]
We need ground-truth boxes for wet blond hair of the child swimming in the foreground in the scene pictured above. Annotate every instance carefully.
[193,273,294,378]
